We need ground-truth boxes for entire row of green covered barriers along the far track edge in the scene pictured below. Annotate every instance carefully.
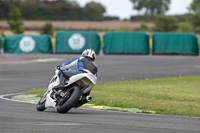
[0,31,199,56]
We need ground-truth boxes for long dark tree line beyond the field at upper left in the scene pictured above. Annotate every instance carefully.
[0,0,119,21]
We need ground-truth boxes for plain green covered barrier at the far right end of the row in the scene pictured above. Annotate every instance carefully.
[153,32,199,55]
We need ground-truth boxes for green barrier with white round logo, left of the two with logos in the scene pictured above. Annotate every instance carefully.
[4,35,53,54]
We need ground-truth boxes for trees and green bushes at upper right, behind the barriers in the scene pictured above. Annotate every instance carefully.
[130,0,200,33]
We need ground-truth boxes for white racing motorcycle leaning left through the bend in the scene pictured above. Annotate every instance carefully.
[36,69,97,113]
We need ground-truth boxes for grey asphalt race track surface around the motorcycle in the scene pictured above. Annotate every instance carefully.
[0,54,200,133]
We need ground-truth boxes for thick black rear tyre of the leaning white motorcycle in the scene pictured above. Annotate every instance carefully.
[57,86,81,113]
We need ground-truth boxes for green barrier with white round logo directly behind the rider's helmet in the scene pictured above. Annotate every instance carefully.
[55,31,100,54]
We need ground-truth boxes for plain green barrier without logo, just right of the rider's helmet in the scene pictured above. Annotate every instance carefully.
[103,32,149,55]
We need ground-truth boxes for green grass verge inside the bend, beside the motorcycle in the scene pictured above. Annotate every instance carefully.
[26,76,200,117]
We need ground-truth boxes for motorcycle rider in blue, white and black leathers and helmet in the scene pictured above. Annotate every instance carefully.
[53,49,98,107]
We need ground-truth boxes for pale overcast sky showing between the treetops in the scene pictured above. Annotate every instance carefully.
[72,0,193,19]
